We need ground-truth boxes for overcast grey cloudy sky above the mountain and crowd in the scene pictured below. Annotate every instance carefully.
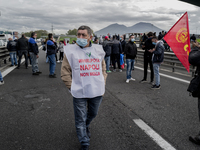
[0,0,200,34]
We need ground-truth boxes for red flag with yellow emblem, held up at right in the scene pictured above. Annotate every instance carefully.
[164,12,191,72]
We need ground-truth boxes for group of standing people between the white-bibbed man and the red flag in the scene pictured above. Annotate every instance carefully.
[99,32,165,89]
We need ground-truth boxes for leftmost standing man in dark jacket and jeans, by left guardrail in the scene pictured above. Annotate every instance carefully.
[7,38,17,66]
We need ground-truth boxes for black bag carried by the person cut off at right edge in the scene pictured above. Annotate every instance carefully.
[187,75,200,97]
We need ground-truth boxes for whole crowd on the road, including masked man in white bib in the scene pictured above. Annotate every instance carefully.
[0,26,200,150]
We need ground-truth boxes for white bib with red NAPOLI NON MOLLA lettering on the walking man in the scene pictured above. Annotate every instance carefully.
[64,44,105,98]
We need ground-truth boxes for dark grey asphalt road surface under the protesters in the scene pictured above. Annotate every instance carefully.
[0,48,200,150]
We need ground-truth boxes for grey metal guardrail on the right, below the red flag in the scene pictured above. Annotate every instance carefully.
[136,50,195,77]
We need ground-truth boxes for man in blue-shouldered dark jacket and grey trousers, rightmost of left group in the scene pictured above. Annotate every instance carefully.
[28,32,42,75]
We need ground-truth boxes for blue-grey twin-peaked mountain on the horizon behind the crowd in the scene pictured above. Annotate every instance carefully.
[95,22,163,36]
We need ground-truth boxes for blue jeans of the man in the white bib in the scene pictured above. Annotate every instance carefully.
[73,96,103,145]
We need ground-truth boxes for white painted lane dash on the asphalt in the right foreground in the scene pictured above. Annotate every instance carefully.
[133,119,176,150]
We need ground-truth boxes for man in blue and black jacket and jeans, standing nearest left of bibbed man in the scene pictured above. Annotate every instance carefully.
[47,34,57,78]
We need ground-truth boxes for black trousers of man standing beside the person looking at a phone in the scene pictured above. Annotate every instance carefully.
[143,55,154,81]
